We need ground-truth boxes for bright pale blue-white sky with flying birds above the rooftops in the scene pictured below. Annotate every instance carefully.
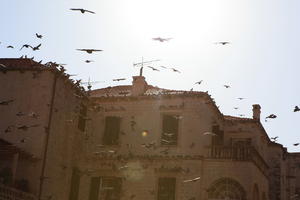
[0,0,300,152]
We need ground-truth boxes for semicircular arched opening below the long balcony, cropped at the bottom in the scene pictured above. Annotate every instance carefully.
[207,178,246,200]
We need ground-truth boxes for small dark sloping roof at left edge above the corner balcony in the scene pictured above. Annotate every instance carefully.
[0,139,37,161]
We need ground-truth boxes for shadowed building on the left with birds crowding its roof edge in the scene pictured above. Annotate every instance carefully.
[0,59,86,200]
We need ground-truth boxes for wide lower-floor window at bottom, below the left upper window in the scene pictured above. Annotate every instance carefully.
[89,177,122,200]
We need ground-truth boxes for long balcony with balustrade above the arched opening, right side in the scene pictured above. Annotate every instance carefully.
[205,146,269,177]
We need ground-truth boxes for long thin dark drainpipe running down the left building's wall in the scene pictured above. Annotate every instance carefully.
[38,72,58,200]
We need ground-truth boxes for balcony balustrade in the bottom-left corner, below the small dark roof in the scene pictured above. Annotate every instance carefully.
[0,184,37,200]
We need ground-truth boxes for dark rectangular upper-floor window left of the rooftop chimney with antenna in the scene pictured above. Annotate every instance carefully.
[103,116,121,145]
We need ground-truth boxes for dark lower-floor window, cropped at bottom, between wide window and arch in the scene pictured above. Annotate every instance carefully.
[157,177,176,200]
